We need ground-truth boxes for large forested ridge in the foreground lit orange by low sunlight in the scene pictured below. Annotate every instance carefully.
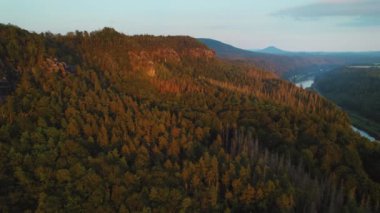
[0,25,380,212]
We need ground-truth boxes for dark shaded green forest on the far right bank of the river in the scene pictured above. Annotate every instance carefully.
[315,66,380,139]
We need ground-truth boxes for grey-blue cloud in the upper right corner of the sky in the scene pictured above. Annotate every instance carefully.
[273,0,380,26]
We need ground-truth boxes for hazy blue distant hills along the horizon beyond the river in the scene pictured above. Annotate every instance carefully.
[198,38,380,79]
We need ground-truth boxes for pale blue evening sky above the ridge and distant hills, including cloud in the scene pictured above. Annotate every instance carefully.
[0,0,380,51]
